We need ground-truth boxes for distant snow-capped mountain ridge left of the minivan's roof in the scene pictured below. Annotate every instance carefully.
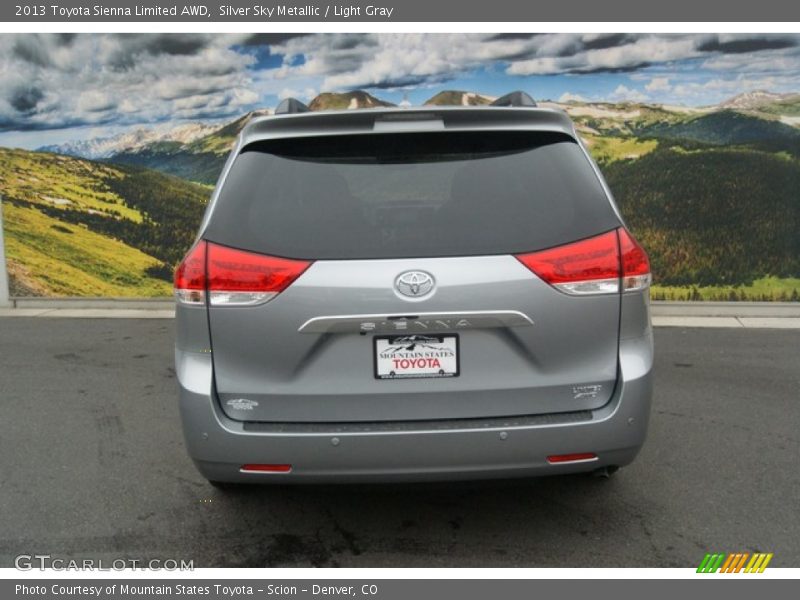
[39,123,221,159]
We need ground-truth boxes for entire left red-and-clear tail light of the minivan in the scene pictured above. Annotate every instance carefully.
[175,241,311,306]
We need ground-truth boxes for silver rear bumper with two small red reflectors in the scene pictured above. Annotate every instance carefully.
[176,332,652,484]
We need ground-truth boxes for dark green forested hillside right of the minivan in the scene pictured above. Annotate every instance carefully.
[604,144,800,286]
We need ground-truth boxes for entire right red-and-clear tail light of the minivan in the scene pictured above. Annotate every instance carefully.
[517,227,650,295]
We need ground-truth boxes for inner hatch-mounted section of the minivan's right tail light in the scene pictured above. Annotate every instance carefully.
[517,231,619,295]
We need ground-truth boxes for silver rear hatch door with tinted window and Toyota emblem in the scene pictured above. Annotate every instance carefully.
[204,132,620,422]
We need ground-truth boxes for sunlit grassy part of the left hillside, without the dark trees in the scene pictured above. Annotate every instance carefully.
[0,148,206,296]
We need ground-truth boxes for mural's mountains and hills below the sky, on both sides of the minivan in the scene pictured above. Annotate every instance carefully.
[0,90,800,300]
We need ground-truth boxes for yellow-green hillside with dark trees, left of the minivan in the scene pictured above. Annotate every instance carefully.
[0,148,209,296]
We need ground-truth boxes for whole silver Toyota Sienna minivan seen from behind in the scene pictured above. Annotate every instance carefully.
[175,92,653,483]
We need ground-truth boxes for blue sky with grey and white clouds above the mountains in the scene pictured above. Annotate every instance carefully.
[0,33,800,148]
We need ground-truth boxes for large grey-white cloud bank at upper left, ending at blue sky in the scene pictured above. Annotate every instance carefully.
[0,34,258,129]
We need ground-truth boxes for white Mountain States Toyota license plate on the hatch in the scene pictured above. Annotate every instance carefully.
[374,334,458,379]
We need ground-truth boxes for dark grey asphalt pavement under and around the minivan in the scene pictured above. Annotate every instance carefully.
[0,317,800,567]
